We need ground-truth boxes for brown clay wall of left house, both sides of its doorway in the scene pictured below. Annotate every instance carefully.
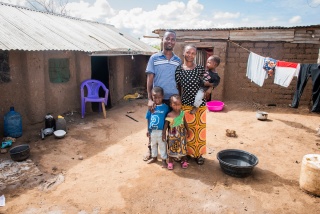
[0,51,149,136]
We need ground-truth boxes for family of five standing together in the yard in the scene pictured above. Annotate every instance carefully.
[144,31,220,170]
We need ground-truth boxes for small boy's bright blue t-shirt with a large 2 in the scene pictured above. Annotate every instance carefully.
[146,103,169,130]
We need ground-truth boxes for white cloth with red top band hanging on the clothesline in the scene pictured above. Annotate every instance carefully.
[274,61,300,87]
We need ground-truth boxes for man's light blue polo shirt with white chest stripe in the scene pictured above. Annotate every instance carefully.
[146,52,181,100]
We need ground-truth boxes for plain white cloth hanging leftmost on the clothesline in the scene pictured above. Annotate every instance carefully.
[246,52,268,87]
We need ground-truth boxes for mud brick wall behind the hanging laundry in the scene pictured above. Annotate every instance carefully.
[224,42,320,105]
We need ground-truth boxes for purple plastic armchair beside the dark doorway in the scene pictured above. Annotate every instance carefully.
[80,79,109,118]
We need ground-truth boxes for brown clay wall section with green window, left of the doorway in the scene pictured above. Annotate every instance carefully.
[0,51,91,135]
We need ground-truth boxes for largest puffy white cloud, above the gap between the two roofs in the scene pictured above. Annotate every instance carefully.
[105,0,213,40]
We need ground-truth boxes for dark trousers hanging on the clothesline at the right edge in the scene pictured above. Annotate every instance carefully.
[291,64,320,112]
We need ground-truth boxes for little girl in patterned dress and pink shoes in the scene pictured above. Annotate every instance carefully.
[162,94,189,170]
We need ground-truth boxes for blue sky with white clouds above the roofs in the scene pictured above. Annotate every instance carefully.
[0,0,320,45]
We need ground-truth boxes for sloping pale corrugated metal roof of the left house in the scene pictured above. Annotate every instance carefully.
[0,3,158,55]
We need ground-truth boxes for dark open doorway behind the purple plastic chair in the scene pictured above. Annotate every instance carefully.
[91,56,111,111]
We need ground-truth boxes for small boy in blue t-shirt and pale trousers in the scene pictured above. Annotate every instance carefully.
[146,86,169,168]
